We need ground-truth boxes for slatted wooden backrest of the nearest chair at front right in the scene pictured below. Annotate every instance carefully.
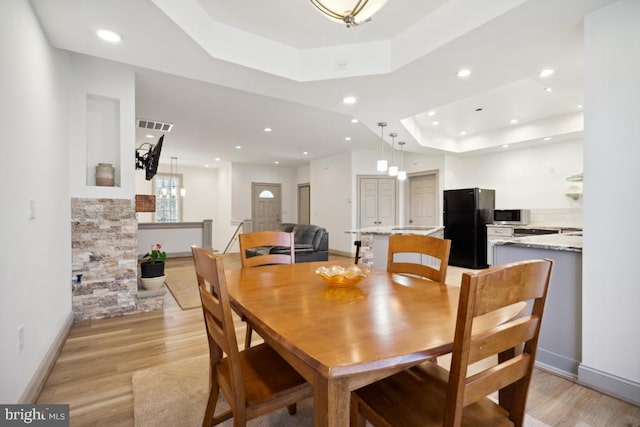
[444,260,553,425]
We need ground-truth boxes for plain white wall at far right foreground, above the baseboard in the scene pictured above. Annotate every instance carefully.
[579,0,640,403]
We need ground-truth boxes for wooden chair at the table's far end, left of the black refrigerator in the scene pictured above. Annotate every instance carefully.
[387,234,451,283]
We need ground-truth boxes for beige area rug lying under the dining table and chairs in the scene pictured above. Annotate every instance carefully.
[132,355,549,427]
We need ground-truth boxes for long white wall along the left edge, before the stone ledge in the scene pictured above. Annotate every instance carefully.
[0,0,72,403]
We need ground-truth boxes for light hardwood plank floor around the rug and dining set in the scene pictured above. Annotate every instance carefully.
[37,254,640,427]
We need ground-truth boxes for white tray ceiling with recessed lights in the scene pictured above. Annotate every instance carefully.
[32,0,613,166]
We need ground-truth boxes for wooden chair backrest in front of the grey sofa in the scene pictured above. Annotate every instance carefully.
[238,231,296,267]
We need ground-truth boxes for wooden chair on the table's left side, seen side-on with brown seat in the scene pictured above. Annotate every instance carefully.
[192,247,313,426]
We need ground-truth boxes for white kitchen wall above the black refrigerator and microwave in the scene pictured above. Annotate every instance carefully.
[445,141,583,209]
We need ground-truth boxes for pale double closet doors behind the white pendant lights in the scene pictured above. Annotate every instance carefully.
[358,178,396,227]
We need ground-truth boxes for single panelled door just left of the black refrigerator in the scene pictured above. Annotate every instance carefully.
[409,173,438,225]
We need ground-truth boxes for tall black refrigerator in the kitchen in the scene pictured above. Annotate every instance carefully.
[444,188,495,269]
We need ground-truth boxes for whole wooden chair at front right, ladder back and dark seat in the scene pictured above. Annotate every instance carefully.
[351,260,552,427]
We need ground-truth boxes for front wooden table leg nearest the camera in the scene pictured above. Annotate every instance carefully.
[313,375,351,427]
